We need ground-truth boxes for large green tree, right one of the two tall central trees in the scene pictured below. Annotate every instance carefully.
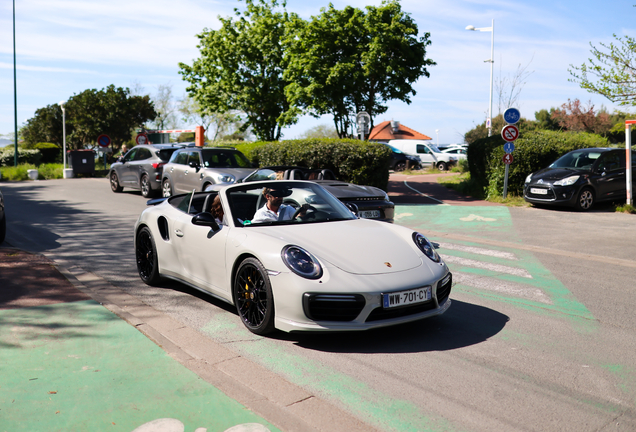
[284,0,435,137]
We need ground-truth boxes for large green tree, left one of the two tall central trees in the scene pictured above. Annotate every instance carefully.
[179,0,299,141]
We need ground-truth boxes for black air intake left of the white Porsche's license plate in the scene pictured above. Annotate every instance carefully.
[303,293,366,321]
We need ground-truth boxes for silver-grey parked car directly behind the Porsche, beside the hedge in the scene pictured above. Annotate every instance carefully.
[162,147,254,197]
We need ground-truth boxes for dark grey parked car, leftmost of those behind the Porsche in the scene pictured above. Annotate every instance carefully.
[108,144,182,198]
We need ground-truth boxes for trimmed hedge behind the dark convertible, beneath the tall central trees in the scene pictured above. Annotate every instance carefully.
[250,138,391,191]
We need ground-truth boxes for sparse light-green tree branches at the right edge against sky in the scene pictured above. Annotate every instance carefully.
[568,34,636,105]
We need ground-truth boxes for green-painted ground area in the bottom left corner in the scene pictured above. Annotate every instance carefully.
[0,300,278,432]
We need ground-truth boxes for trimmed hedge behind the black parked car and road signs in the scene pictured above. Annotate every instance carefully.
[468,131,609,197]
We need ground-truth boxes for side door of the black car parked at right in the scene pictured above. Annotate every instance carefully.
[592,150,627,200]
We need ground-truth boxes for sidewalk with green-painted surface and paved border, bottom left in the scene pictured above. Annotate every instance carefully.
[0,243,372,432]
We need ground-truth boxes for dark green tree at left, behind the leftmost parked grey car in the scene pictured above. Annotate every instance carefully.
[66,84,157,149]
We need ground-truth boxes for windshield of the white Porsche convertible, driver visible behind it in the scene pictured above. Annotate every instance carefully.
[227,180,357,227]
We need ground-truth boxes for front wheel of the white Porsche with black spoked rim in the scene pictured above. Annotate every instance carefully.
[234,258,274,335]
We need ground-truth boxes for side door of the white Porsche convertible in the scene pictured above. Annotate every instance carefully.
[172,199,232,298]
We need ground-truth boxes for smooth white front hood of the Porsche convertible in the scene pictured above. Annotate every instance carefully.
[256,220,422,274]
